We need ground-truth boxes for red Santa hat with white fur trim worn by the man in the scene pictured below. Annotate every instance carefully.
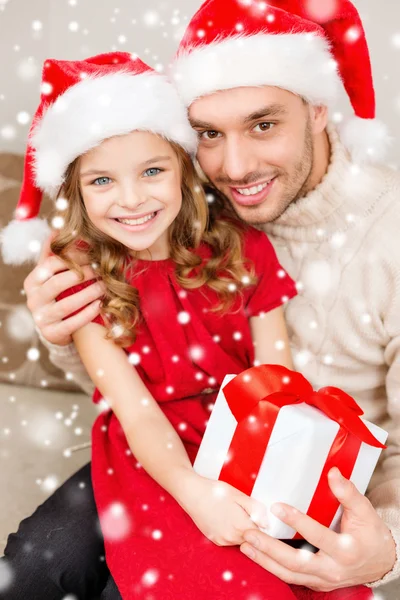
[171,0,389,162]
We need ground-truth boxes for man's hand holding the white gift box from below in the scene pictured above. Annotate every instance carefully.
[241,468,396,591]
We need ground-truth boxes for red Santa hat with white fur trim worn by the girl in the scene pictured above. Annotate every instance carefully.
[1,52,197,264]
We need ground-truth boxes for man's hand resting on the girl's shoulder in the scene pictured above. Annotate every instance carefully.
[24,236,105,346]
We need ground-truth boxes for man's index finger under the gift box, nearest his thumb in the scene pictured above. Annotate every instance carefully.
[271,503,339,556]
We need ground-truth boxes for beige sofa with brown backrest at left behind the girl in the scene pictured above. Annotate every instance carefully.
[0,153,96,553]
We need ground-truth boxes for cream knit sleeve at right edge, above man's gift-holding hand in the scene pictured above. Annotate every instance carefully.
[367,266,400,587]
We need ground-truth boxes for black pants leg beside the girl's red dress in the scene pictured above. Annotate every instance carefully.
[0,464,121,600]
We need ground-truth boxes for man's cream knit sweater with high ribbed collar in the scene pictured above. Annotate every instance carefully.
[43,127,400,586]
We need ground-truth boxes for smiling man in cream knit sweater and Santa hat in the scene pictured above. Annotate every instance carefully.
[1,0,400,590]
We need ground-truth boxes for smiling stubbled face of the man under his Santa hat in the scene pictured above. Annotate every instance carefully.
[189,86,325,224]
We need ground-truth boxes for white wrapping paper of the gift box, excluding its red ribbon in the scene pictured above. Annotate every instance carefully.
[194,375,388,539]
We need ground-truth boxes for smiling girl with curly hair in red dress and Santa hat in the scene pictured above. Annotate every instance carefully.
[0,53,372,600]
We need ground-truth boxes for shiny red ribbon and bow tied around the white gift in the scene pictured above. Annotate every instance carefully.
[219,365,386,538]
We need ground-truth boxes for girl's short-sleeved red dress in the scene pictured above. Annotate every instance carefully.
[61,228,372,600]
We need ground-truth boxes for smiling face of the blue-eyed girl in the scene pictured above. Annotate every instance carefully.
[79,131,182,260]
